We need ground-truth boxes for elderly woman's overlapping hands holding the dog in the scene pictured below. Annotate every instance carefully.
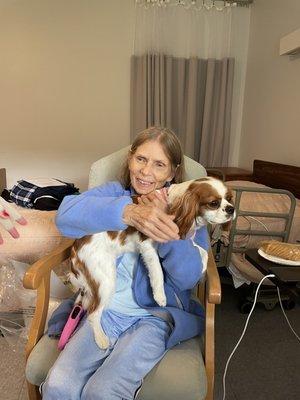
[123,192,179,243]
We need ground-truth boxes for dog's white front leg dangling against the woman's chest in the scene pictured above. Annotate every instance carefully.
[140,240,167,307]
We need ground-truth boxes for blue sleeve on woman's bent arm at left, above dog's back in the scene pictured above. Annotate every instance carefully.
[56,182,132,238]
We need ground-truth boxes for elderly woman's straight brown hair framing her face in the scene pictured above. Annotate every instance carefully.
[120,126,184,189]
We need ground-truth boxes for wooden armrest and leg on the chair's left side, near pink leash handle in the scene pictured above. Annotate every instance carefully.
[23,239,74,359]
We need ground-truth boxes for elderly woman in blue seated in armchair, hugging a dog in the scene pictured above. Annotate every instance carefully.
[41,128,208,400]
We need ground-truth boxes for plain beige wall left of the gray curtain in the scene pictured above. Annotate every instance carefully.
[0,0,134,189]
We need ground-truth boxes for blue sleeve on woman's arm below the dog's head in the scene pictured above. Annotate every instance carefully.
[157,227,209,290]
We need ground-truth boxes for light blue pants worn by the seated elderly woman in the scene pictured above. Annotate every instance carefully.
[41,311,170,400]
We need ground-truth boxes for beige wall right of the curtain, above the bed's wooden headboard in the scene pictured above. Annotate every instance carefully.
[239,0,300,168]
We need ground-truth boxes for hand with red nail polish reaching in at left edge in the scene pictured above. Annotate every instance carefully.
[0,197,27,244]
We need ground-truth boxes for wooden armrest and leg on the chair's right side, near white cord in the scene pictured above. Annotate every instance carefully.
[197,249,221,400]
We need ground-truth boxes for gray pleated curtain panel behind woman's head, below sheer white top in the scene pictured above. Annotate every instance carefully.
[131,54,234,167]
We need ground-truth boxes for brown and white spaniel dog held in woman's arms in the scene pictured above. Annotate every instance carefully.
[70,177,234,348]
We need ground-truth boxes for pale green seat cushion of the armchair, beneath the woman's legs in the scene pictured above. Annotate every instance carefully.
[25,335,207,400]
